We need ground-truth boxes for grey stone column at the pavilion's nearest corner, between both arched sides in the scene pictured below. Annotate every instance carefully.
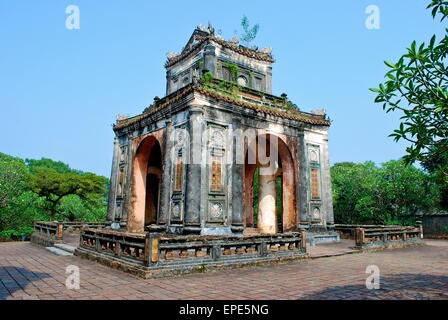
[184,107,203,232]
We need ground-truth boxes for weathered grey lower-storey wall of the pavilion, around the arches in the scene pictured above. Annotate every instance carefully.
[108,91,333,234]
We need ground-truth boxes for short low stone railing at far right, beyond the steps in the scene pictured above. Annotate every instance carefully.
[355,226,423,249]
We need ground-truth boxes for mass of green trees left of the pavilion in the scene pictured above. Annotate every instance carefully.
[0,153,109,238]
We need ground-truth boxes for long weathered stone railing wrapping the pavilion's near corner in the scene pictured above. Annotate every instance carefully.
[75,228,306,277]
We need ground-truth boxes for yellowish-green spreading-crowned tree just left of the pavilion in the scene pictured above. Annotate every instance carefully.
[30,167,107,220]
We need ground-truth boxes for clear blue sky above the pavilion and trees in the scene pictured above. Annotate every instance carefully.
[0,0,445,176]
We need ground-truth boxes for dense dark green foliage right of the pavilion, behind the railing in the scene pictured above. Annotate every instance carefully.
[331,160,439,224]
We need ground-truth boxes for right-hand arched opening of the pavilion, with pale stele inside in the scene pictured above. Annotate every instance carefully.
[244,134,297,233]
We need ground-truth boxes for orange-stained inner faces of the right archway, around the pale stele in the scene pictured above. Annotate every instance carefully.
[243,133,297,232]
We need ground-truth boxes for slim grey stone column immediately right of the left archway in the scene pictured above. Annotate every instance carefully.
[157,120,174,224]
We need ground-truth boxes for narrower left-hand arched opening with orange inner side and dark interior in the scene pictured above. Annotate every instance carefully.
[128,135,162,232]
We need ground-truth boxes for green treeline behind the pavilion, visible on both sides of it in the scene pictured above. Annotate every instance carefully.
[0,153,448,238]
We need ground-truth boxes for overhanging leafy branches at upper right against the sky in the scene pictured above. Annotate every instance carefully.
[370,0,448,168]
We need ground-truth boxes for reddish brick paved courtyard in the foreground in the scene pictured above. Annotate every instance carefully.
[0,240,448,300]
